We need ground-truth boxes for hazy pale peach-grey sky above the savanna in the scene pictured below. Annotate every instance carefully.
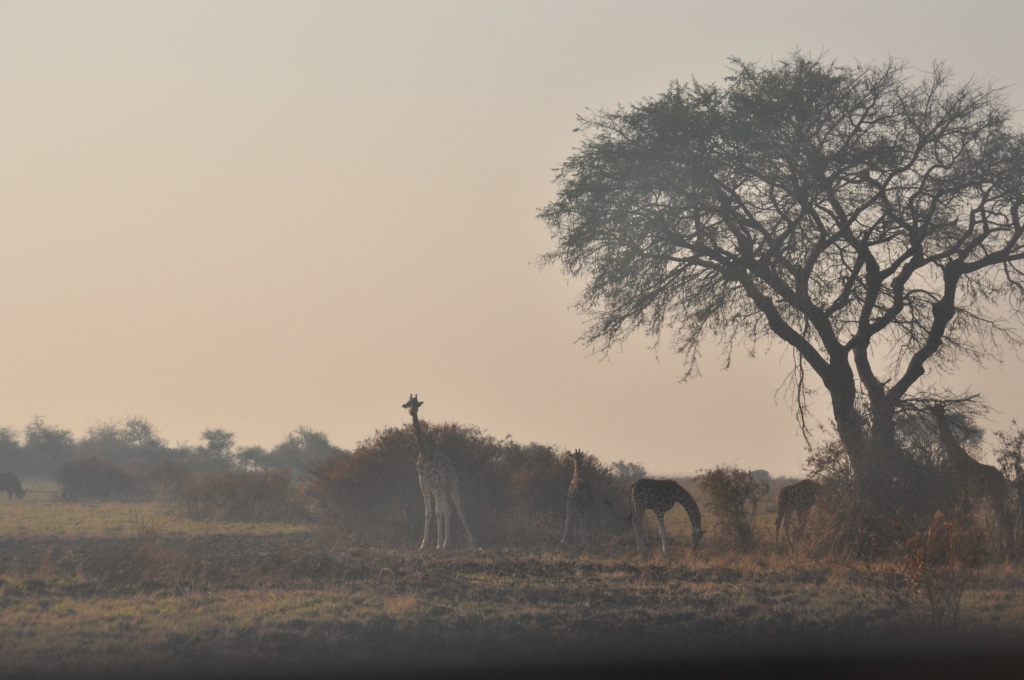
[0,0,1024,474]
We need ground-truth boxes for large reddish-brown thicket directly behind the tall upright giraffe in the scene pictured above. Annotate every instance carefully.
[308,421,630,547]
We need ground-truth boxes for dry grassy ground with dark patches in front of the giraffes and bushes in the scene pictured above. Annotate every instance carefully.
[0,486,1024,677]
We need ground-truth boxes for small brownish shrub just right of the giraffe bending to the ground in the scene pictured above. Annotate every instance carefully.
[697,467,768,549]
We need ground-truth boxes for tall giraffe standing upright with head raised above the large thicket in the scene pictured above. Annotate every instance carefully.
[401,394,476,550]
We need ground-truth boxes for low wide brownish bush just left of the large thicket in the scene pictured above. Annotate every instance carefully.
[178,470,308,522]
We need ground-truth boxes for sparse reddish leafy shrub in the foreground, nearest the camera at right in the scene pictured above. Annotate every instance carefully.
[869,512,982,629]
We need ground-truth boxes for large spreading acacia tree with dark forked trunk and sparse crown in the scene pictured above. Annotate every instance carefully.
[541,53,1024,500]
